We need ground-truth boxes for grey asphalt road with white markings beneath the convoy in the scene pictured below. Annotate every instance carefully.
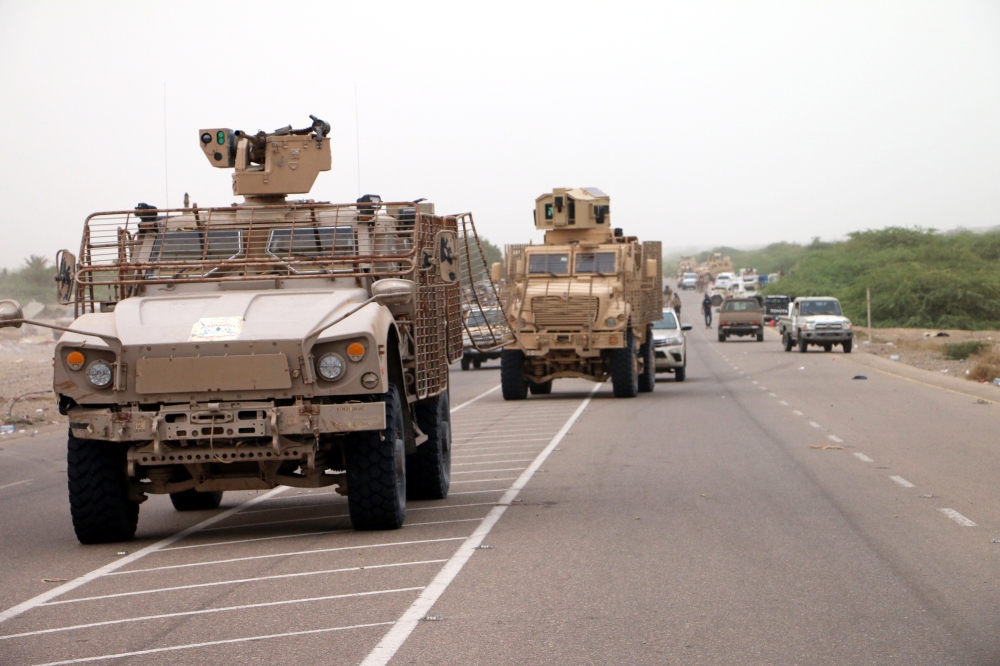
[0,294,1000,666]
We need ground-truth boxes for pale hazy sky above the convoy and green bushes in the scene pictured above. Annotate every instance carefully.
[0,0,1000,267]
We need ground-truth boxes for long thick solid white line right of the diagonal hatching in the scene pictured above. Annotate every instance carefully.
[361,384,601,666]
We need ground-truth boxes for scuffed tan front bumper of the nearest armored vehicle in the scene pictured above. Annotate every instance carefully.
[69,402,385,446]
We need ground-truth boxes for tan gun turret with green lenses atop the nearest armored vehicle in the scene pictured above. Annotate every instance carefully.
[198,116,330,197]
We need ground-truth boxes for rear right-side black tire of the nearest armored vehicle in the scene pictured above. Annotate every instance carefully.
[406,391,451,500]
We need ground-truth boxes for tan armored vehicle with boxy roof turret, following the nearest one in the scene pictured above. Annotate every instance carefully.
[500,187,663,400]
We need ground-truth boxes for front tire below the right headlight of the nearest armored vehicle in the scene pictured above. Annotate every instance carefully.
[345,384,406,530]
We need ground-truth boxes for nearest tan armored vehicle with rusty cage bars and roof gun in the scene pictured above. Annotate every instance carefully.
[0,118,503,543]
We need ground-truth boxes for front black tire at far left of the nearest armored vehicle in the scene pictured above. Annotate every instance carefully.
[66,432,139,543]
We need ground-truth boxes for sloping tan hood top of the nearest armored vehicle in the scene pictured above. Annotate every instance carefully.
[69,289,368,347]
